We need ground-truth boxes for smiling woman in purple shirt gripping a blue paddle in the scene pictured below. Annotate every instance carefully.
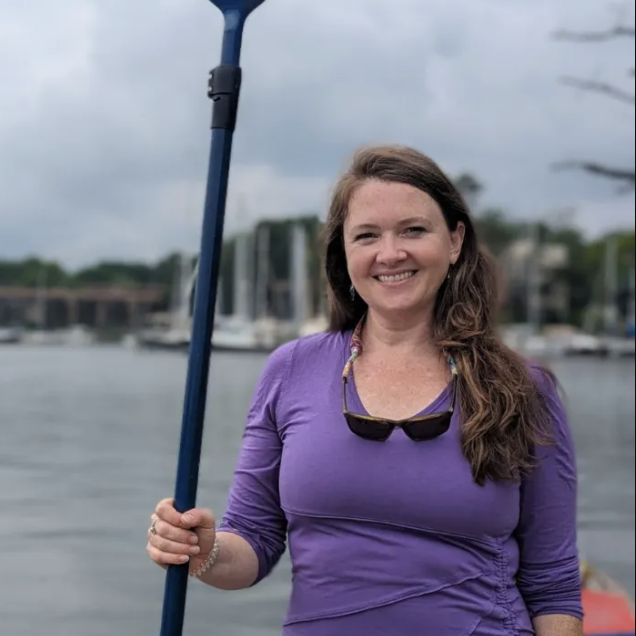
[148,147,582,636]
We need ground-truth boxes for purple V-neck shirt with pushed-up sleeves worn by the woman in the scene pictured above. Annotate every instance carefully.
[220,332,582,636]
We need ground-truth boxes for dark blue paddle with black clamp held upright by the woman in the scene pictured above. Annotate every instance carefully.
[161,0,264,636]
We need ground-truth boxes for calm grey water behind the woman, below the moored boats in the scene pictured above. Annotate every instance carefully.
[0,347,634,636]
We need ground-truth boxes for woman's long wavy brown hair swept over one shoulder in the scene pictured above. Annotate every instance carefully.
[325,146,549,485]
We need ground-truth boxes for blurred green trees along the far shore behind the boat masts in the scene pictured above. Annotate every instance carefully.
[0,175,635,325]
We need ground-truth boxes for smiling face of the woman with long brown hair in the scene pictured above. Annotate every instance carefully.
[344,180,465,317]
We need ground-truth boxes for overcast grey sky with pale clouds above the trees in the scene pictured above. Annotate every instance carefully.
[0,0,634,268]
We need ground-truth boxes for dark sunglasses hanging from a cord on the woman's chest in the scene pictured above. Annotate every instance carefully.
[342,373,457,442]
